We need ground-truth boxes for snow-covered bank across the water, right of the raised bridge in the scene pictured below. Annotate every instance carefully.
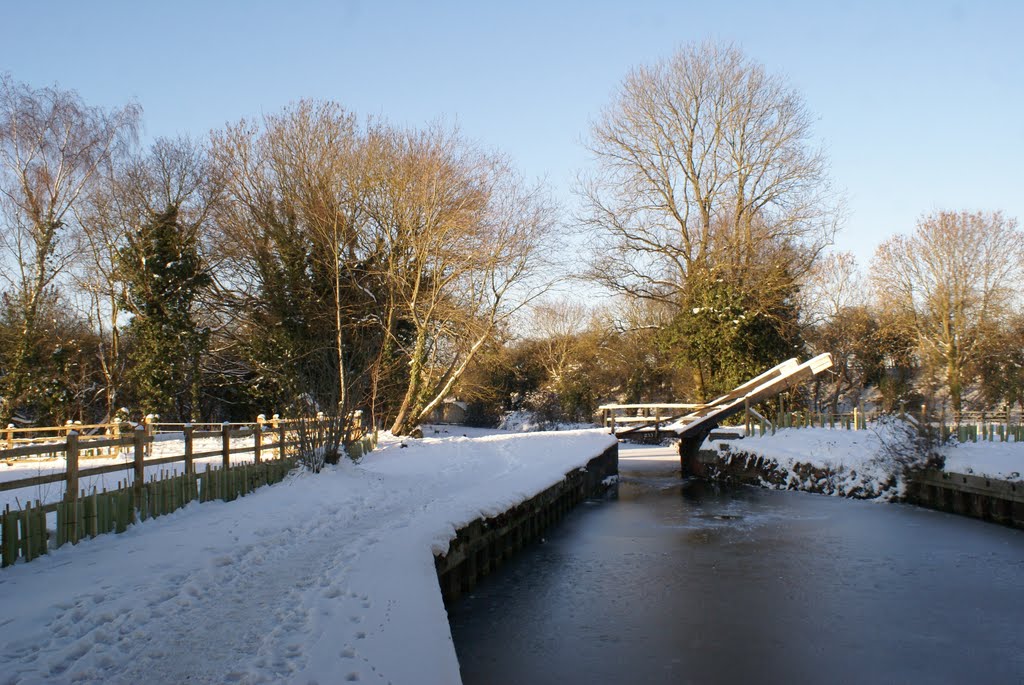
[708,422,1024,500]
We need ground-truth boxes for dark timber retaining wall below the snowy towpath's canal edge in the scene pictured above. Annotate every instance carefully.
[434,444,618,602]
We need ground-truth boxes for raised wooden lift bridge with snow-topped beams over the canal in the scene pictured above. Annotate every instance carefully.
[599,352,833,476]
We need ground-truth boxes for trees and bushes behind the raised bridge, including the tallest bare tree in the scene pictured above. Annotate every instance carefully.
[458,43,1024,421]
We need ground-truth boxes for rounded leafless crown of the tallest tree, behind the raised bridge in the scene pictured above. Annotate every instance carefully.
[581,43,840,305]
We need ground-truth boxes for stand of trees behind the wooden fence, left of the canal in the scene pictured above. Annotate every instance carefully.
[0,76,553,432]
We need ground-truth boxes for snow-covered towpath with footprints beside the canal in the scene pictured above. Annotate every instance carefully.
[0,431,612,684]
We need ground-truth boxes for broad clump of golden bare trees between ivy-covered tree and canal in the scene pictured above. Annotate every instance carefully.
[213,102,552,432]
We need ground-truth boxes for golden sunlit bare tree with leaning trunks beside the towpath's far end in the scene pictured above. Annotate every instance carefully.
[368,126,553,433]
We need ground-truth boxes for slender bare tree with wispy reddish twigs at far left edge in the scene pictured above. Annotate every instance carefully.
[0,75,140,422]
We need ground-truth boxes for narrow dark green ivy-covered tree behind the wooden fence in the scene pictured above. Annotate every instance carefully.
[119,205,211,420]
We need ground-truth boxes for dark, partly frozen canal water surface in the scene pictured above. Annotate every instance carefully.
[449,454,1024,685]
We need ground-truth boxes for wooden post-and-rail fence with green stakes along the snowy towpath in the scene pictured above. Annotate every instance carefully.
[0,417,377,566]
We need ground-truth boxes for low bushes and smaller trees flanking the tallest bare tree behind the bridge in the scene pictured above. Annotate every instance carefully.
[481,202,1024,424]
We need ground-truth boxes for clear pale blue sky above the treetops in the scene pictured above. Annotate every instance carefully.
[0,0,1024,264]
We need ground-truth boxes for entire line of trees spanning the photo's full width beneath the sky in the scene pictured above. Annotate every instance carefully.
[0,42,1024,433]
